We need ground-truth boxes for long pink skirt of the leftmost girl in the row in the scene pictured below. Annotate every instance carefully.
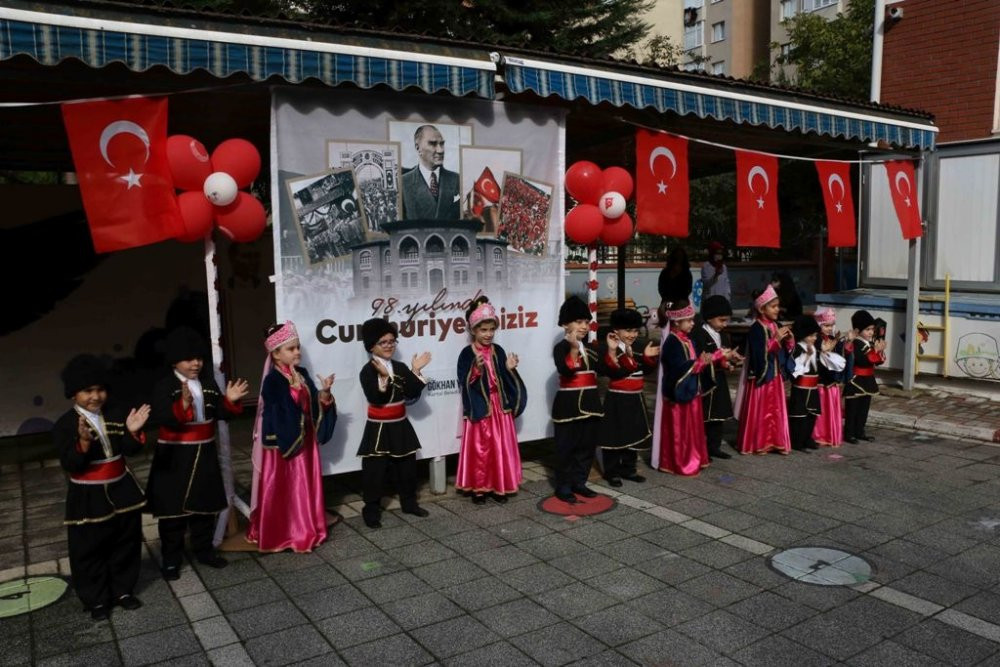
[247,444,326,553]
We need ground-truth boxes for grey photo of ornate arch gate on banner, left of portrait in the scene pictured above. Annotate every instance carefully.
[326,139,403,234]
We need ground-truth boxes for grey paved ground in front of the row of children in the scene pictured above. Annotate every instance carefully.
[7,412,1000,666]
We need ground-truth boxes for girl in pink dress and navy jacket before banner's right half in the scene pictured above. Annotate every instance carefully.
[455,296,528,504]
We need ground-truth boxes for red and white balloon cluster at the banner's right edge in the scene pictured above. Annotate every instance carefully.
[566,160,634,245]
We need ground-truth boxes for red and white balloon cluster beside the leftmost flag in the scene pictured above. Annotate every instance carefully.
[167,134,267,243]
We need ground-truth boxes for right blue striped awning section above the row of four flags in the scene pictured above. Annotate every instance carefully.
[503,56,937,150]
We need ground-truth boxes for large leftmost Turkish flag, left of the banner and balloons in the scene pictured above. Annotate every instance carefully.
[62,97,184,252]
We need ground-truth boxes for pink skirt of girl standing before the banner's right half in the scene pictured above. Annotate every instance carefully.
[455,391,521,495]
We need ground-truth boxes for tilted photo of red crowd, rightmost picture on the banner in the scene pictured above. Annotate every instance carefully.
[497,172,554,257]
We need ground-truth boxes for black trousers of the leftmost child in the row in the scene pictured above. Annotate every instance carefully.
[66,510,142,609]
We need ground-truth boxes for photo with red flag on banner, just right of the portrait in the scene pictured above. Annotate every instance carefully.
[461,146,522,236]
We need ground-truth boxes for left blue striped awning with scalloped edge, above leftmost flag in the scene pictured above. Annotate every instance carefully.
[0,7,496,99]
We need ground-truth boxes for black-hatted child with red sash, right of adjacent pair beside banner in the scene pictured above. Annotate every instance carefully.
[597,308,660,487]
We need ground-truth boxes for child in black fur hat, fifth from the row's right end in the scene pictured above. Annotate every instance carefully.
[691,294,743,459]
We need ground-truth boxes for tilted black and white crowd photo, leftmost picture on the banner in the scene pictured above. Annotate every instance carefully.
[286,169,367,264]
